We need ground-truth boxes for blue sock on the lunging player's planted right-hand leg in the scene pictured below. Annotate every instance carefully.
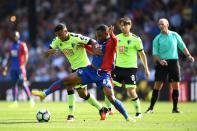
[112,99,129,120]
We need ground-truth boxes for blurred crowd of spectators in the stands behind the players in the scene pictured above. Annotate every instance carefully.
[0,0,197,81]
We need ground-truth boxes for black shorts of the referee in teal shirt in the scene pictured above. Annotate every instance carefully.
[155,60,180,82]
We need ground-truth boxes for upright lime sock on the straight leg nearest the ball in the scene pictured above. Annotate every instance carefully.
[67,90,75,115]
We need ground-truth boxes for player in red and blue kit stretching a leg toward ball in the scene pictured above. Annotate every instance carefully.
[33,24,135,121]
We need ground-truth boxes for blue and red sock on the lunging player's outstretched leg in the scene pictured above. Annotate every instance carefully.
[44,80,64,96]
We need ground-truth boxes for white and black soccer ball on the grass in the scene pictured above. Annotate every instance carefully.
[36,109,51,122]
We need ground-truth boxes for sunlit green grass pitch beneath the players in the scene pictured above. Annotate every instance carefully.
[0,102,197,131]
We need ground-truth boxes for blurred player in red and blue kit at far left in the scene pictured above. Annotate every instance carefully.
[3,31,35,108]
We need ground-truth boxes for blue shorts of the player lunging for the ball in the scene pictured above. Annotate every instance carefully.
[77,66,113,89]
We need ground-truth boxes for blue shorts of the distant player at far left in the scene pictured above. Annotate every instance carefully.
[10,68,27,83]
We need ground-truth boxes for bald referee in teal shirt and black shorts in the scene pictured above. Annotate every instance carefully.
[146,18,194,113]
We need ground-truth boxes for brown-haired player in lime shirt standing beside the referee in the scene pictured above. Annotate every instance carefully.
[112,17,150,118]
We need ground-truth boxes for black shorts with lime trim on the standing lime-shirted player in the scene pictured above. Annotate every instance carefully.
[112,66,137,88]
